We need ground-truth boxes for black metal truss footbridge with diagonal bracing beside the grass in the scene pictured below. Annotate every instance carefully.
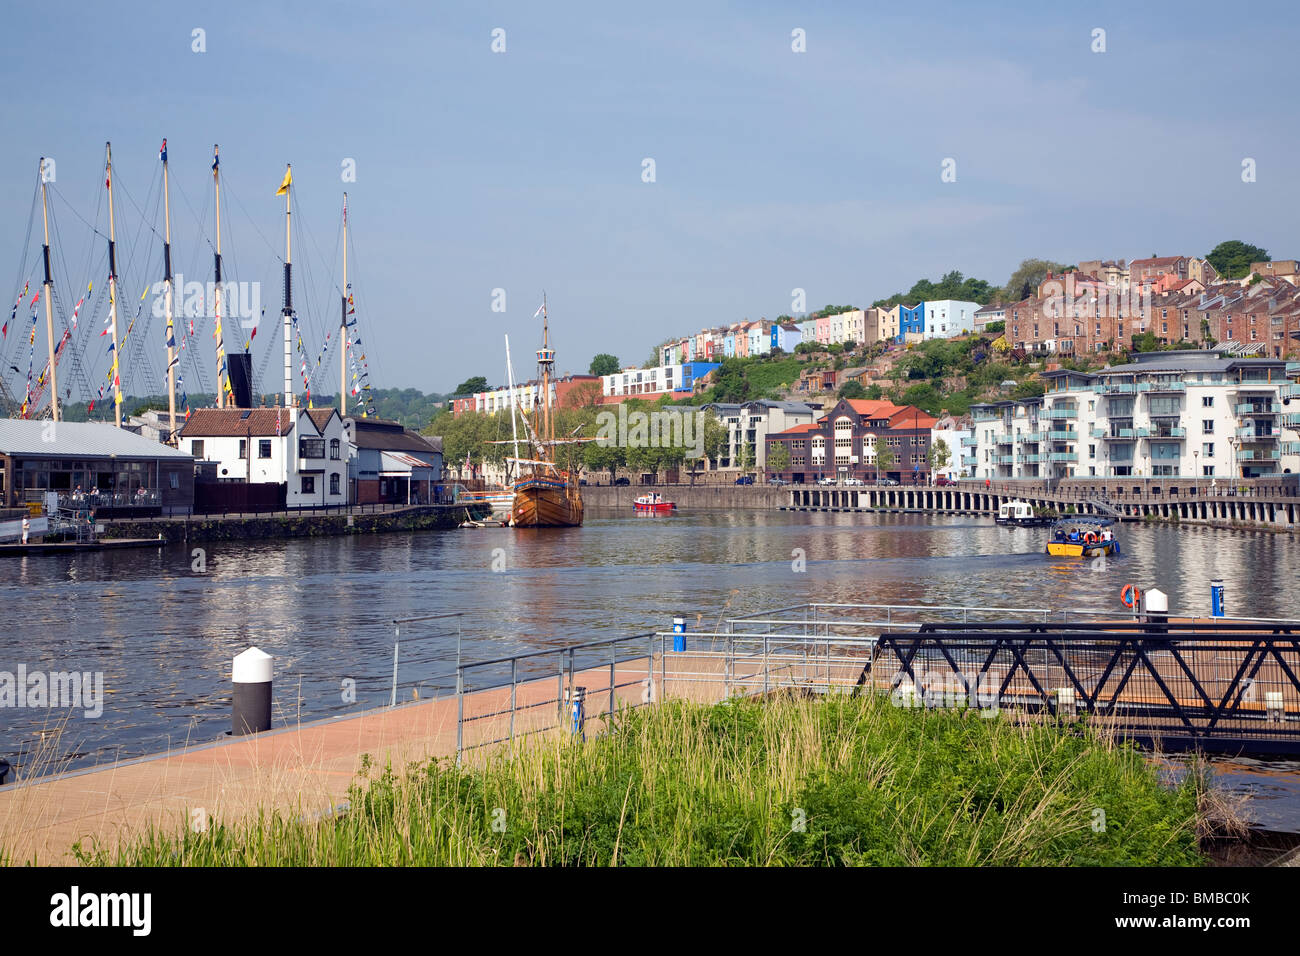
[868,620,1300,753]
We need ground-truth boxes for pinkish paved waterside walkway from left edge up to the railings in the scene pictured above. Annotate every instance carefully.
[0,654,722,865]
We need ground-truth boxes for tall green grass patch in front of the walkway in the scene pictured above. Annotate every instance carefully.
[78,696,1201,866]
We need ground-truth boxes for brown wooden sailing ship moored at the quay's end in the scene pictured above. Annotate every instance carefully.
[510,297,590,528]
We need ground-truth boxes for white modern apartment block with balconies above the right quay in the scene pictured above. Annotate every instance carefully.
[962,351,1300,480]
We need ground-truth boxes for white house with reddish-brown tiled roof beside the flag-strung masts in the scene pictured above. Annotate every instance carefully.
[181,408,348,507]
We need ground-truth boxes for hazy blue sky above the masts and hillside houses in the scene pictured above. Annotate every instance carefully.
[0,0,1300,401]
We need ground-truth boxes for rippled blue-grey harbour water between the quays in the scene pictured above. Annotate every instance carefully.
[0,512,1300,832]
